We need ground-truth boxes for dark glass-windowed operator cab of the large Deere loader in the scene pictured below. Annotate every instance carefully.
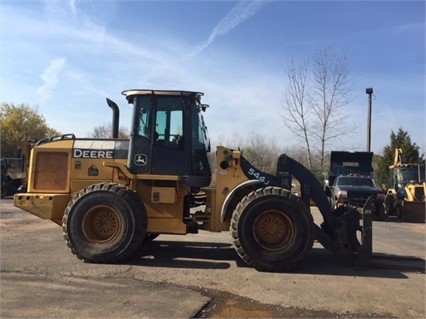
[122,90,211,187]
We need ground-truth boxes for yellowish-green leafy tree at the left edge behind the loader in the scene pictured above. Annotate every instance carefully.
[0,102,60,157]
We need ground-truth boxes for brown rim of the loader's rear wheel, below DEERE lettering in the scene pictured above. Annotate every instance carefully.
[81,205,122,244]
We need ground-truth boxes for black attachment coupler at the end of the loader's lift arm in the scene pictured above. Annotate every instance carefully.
[333,197,373,267]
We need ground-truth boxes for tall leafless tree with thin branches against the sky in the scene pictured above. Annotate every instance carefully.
[282,47,355,169]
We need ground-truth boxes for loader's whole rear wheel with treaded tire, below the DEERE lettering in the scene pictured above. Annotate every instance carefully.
[62,183,147,263]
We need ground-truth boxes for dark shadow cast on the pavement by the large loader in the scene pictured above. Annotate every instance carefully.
[129,239,425,279]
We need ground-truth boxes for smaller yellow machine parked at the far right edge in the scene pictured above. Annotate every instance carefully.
[385,148,426,223]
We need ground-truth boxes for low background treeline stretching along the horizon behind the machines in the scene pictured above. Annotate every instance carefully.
[0,102,424,187]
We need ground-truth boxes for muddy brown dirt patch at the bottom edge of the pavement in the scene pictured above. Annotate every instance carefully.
[192,289,393,318]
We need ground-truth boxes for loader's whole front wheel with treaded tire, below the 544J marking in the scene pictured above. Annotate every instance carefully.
[230,187,314,272]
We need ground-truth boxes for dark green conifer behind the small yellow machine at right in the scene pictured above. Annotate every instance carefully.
[376,128,424,187]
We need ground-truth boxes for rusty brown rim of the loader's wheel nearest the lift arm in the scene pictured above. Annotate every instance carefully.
[253,210,296,251]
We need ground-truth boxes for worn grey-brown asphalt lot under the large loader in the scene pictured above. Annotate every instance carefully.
[0,199,426,318]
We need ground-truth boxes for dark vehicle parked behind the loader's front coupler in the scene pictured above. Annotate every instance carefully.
[330,176,385,219]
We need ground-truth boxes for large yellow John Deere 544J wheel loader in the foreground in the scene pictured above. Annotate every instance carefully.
[14,90,372,271]
